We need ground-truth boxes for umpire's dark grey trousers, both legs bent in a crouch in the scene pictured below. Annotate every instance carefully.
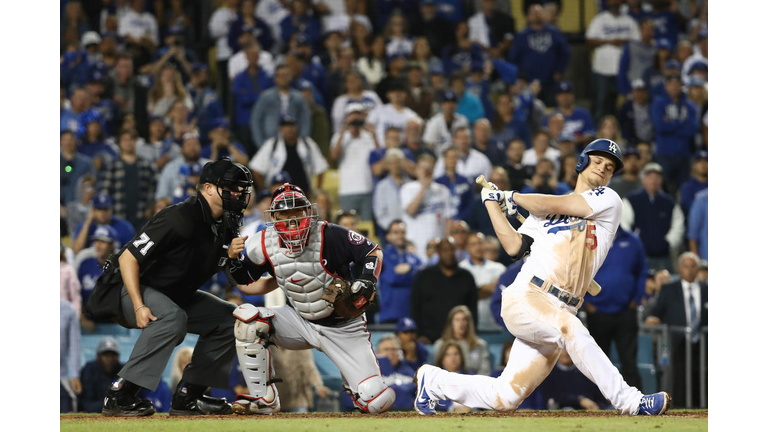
[118,286,236,391]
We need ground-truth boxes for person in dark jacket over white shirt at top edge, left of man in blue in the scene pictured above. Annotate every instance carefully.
[468,0,515,58]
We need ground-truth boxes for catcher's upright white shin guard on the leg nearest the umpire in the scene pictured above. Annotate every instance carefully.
[232,304,280,414]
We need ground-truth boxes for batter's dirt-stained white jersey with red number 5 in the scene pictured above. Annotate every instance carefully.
[518,186,622,297]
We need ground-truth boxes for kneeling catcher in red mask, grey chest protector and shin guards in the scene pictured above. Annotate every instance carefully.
[220,183,395,414]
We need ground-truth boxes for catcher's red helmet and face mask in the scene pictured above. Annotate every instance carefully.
[264,183,319,255]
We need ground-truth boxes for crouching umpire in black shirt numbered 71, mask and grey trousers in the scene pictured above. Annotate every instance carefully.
[86,159,253,417]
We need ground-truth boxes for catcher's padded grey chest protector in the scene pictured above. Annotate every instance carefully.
[264,221,334,320]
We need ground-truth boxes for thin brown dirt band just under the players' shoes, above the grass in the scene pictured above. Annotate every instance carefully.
[60,410,709,421]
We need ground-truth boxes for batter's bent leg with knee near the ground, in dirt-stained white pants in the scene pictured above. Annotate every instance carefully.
[416,338,560,414]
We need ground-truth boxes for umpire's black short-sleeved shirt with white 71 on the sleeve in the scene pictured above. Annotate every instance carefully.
[114,194,232,305]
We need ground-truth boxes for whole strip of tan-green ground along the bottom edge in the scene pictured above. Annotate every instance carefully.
[60,410,708,432]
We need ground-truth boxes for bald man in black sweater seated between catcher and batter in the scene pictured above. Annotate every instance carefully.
[411,237,476,344]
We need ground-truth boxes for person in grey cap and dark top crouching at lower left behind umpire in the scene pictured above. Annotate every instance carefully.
[79,336,123,413]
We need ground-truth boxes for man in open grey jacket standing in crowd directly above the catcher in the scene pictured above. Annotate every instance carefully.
[250,65,312,150]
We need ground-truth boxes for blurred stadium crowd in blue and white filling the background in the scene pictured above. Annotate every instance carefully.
[60,0,708,412]
